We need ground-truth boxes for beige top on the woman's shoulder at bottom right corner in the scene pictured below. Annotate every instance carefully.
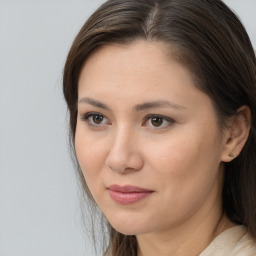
[199,226,256,256]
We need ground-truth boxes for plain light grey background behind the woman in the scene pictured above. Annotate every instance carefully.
[0,0,256,256]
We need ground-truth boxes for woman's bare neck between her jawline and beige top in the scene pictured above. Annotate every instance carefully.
[136,188,235,256]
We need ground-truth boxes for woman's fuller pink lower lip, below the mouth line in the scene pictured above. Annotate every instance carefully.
[109,190,152,205]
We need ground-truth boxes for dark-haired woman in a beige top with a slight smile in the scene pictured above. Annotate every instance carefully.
[63,0,256,256]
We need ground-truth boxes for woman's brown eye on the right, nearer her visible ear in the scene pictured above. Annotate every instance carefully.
[143,115,175,129]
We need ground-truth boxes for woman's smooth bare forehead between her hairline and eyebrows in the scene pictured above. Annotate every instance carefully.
[79,40,194,96]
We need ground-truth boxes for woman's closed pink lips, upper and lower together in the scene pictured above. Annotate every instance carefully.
[107,185,154,205]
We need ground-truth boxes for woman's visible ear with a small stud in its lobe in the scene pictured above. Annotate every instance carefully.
[221,106,251,162]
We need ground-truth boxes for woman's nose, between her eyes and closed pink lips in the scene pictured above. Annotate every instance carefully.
[106,126,143,173]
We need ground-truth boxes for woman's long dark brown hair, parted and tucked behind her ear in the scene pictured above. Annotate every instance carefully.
[63,0,256,256]
